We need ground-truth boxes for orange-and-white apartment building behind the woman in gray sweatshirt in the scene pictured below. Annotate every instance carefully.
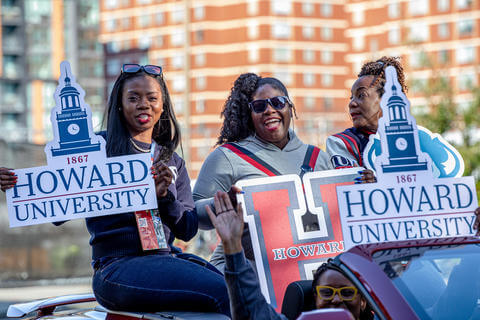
[100,0,350,177]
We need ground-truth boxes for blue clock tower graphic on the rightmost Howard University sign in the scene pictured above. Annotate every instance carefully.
[382,74,427,172]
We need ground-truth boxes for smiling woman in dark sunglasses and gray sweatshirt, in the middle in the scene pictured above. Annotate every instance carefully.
[193,73,331,271]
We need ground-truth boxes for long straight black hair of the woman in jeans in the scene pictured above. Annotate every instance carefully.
[106,71,181,161]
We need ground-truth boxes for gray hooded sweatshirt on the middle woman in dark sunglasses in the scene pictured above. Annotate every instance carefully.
[193,130,333,272]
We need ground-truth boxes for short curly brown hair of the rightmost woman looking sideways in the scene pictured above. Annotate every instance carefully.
[358,56,408,97]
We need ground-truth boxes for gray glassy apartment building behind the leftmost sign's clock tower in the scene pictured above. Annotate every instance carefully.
[0,0,105,144]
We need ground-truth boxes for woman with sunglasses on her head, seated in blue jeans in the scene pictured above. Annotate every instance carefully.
[0,64,230,315]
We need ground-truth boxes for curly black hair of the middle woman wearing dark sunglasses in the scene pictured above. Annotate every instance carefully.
[216,73,297,145]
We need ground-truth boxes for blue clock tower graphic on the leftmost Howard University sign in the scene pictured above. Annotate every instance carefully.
[51,63,100,157]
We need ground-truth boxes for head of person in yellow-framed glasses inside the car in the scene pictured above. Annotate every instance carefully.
[312,262,373,320]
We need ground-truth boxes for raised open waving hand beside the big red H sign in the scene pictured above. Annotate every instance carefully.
[205,191,243,254]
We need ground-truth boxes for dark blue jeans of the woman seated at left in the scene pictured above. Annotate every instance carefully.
[93,254,230,316]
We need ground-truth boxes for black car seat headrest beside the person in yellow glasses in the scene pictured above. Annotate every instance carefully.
[282,280,315,320]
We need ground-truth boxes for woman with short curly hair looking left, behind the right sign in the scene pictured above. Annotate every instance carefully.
[327,56,407,181]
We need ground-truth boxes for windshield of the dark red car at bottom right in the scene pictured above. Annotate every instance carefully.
[373,244,480,320]
